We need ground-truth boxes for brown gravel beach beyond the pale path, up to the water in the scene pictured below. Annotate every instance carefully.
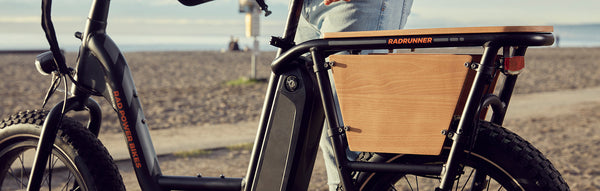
[0,48,600,132]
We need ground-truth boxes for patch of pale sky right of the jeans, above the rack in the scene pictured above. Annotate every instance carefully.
[407,0,600,28]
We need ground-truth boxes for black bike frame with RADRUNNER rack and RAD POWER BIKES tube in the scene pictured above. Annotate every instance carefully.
[29,0,553,191]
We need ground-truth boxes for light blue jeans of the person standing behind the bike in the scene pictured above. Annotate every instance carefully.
[295,0,413,190]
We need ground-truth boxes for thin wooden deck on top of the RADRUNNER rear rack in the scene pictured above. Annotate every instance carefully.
[323,26,554,39]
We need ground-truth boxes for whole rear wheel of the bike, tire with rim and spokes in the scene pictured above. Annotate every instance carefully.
[356,122,569,191]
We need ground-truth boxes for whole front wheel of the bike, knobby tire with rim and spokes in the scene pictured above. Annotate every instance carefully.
[0,111,125,190]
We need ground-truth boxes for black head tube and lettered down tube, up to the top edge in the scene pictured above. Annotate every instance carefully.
[74,0,166,190]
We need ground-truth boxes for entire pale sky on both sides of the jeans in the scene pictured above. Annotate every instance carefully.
[0,0,600,50]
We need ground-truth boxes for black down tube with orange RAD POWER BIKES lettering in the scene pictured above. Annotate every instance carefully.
[82,33,162,190]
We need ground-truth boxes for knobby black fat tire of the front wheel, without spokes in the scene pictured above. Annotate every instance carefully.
[0,110,125,191]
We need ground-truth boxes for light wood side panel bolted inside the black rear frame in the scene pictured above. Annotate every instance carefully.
[330,54,472,155]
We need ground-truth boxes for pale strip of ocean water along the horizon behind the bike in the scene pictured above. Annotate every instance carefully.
[0,24,600,52]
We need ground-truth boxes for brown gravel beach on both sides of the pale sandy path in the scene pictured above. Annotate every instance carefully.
[0,48,600,190]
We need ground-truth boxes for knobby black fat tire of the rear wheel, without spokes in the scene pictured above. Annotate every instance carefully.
[354,122,569,191]
